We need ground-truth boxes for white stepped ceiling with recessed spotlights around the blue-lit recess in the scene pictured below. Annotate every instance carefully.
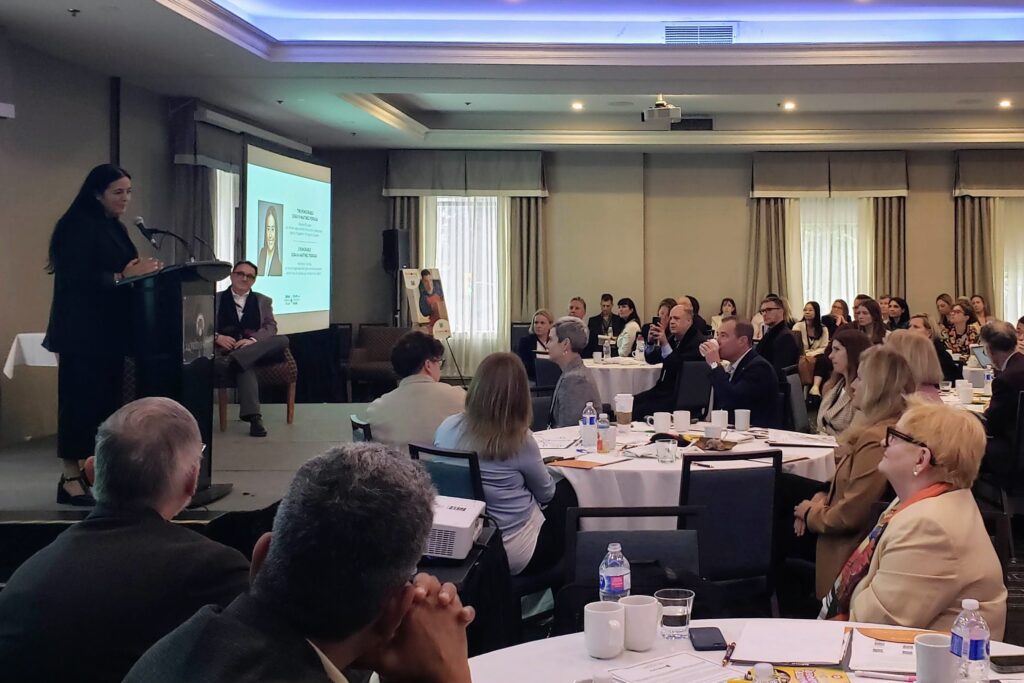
[6,0,1024,151]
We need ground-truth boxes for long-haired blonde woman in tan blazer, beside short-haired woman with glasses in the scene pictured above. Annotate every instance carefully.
[794,347,918,600]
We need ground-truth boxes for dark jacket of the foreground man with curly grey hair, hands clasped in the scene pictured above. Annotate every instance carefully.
[124,595,330,683]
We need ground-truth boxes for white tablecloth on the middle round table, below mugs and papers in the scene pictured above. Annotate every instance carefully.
[536,422,836,529]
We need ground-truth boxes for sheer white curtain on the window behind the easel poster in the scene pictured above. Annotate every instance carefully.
[422,197,509,375]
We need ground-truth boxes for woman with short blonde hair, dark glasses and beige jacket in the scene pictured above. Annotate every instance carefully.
[820,403,1007,640]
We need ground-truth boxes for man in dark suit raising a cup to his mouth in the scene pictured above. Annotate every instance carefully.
[700,316,781,427]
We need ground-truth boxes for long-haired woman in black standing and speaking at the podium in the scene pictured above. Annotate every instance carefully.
[43,164,163,505]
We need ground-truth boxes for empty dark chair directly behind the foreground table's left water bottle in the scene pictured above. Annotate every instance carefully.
[551,506,707,636]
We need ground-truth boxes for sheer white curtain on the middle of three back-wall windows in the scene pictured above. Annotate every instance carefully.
[791,198,874,313]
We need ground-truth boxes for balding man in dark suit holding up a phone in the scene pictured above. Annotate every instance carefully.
[633,304,707,420]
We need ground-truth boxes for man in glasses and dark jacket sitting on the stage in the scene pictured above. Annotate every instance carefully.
[213,261,288,436]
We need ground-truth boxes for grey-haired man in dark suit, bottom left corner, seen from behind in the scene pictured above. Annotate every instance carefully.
[0,398,249,683]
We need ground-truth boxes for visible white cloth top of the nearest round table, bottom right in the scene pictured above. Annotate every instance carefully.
[469,618,1024,683]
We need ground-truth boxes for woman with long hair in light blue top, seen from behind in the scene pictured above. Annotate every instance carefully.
[434,353,565,574]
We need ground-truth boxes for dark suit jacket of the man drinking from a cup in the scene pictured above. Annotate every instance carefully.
[711,352,782,427]
